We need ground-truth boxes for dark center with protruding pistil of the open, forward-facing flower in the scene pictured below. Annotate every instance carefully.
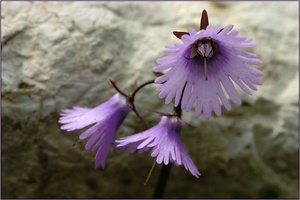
[190,37,219,80]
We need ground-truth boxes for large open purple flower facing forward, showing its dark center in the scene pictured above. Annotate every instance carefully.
[153,22,262,119]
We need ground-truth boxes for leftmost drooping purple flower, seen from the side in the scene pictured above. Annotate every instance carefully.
[59,93,132,168]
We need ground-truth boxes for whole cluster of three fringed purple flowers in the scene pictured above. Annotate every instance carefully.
[59,10,262,178]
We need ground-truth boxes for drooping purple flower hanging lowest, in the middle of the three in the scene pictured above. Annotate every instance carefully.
[116,116,200,178]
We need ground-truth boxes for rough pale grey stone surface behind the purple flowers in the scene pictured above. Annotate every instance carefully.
[1,2,299,198]
